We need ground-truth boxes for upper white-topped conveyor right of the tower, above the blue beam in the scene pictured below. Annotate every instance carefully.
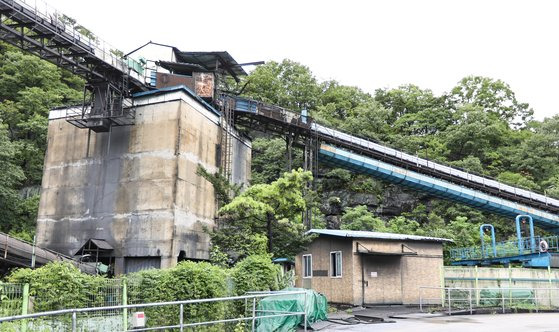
[231,97,559,217]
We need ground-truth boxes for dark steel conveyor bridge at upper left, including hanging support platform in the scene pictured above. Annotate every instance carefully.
[0,0,148,131]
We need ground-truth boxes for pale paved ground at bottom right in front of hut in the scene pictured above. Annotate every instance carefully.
[320,313,559,332]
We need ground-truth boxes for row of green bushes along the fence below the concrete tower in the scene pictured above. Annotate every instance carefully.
[6,255,287,331]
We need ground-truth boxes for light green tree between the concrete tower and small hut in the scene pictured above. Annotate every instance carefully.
[211,169,312,260]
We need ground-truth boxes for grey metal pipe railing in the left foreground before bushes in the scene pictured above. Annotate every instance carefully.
[0,291,308,332]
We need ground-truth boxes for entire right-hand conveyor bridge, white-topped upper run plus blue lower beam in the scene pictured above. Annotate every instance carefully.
[226,97,559,233]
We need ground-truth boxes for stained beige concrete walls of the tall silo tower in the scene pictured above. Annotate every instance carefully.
[37,92,250,273]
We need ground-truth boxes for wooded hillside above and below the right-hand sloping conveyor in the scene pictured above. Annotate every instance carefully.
[237,60,559,249]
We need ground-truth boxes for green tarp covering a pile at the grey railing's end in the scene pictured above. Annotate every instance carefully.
[256,288,328,332]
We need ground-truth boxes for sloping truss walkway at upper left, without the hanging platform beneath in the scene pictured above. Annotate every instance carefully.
[0,0,147,91]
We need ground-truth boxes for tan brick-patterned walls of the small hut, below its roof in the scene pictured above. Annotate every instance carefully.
[295,236,443,305]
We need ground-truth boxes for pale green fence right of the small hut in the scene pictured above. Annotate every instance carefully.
[419,287,559,315]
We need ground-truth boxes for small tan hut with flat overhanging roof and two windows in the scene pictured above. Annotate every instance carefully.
[295,229,452,305]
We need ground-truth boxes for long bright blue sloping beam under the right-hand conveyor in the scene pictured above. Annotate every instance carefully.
[319,144,559,234]
